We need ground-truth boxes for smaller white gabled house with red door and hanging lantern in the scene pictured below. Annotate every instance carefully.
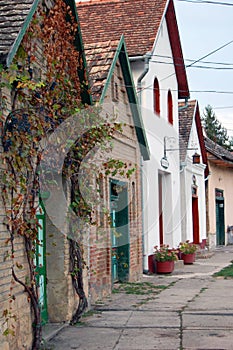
[179,100,209,247]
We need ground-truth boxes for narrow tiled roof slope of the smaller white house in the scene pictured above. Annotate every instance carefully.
[179,100,197,162]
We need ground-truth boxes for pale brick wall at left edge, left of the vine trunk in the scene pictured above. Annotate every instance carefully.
[0,83,32,350]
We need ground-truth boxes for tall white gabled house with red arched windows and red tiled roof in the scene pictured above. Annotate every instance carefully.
[77,0,189,272]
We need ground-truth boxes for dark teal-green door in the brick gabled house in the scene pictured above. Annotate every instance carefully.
[110,180,129,282]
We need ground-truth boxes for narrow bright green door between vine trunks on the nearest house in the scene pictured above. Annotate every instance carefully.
[36,204,48,324]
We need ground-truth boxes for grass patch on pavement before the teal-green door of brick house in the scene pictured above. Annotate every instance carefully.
[112,282,167,295]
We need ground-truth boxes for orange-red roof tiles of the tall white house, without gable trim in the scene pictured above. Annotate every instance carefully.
[76,0,167,56]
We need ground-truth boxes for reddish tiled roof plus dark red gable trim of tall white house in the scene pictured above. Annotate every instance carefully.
[76,0,189,98]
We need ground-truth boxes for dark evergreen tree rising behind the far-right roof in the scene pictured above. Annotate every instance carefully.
[202,105,231,150]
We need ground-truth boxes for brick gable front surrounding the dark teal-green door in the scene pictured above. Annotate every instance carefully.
[89,58,142,302]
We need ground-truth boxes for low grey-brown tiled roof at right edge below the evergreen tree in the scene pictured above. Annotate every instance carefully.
[205,137,233,167]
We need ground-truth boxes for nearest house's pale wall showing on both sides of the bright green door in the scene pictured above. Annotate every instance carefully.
[0,0,81,350]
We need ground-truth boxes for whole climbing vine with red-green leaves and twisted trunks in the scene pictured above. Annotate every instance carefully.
[0,0,134,350]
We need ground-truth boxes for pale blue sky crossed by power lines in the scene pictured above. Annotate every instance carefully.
[174,0,233,136]
